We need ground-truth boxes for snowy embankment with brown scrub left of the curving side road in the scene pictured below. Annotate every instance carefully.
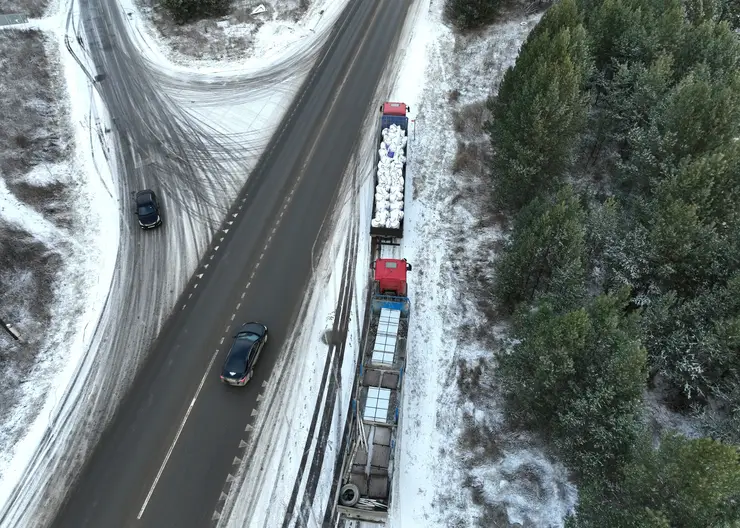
[0,3,119,506]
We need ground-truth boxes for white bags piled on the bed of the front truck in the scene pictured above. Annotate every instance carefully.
[372,125,408,229]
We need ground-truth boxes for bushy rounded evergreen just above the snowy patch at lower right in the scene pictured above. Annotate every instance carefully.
[498,290,646,475]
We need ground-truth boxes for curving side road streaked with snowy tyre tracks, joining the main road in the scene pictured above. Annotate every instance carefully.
[0,0,342,527]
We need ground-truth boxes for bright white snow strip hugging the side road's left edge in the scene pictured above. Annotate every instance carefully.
[0,0,119,508]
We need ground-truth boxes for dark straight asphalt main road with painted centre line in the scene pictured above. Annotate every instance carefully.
[53,0,408,528]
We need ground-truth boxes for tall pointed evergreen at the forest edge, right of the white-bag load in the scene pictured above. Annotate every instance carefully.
[487,8,591,212]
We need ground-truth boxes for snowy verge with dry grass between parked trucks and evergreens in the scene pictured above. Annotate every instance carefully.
[389,0,576,527]
